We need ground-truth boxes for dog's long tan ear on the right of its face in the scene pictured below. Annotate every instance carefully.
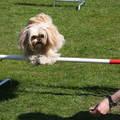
[47,25,65,51]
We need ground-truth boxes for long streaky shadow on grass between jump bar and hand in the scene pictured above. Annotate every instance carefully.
[23,85,118,97]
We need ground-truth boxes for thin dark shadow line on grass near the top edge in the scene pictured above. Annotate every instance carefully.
[14,3,75,7]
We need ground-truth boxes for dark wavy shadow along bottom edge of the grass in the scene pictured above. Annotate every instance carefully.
[18,111,120,120]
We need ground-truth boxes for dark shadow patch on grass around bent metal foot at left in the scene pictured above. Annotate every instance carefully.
[0,80,19,101]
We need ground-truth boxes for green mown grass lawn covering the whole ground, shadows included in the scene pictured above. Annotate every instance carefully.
[0,0,120,120]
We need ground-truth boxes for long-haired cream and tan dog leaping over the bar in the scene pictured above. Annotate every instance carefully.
[18,13,65,65]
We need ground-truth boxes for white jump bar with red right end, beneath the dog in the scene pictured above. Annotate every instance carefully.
[0,55,120,64]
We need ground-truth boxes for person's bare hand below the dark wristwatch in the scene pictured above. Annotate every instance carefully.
[90,98,110,116]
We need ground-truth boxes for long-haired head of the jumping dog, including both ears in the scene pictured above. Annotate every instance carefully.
[18,22,64,52]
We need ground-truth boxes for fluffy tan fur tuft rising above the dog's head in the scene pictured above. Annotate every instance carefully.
[29,13,52,24]
